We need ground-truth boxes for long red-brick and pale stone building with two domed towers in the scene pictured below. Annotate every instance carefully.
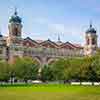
[0,10,97,65]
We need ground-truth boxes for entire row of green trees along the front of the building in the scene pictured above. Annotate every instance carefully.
[0,52,100,82]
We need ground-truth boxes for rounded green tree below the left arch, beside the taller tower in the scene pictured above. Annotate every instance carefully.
[12,57,38,82]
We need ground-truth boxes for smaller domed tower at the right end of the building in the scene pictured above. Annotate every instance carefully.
[84,23,97,56]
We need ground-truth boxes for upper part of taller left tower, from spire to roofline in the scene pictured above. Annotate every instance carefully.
[8,9,22,45]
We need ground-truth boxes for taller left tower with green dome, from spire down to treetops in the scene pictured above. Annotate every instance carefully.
[7,9,23,61]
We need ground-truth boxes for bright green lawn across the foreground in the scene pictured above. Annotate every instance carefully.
[0,85,100,100]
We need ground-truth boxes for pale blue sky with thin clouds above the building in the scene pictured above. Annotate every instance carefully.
[0,0,100,44]
